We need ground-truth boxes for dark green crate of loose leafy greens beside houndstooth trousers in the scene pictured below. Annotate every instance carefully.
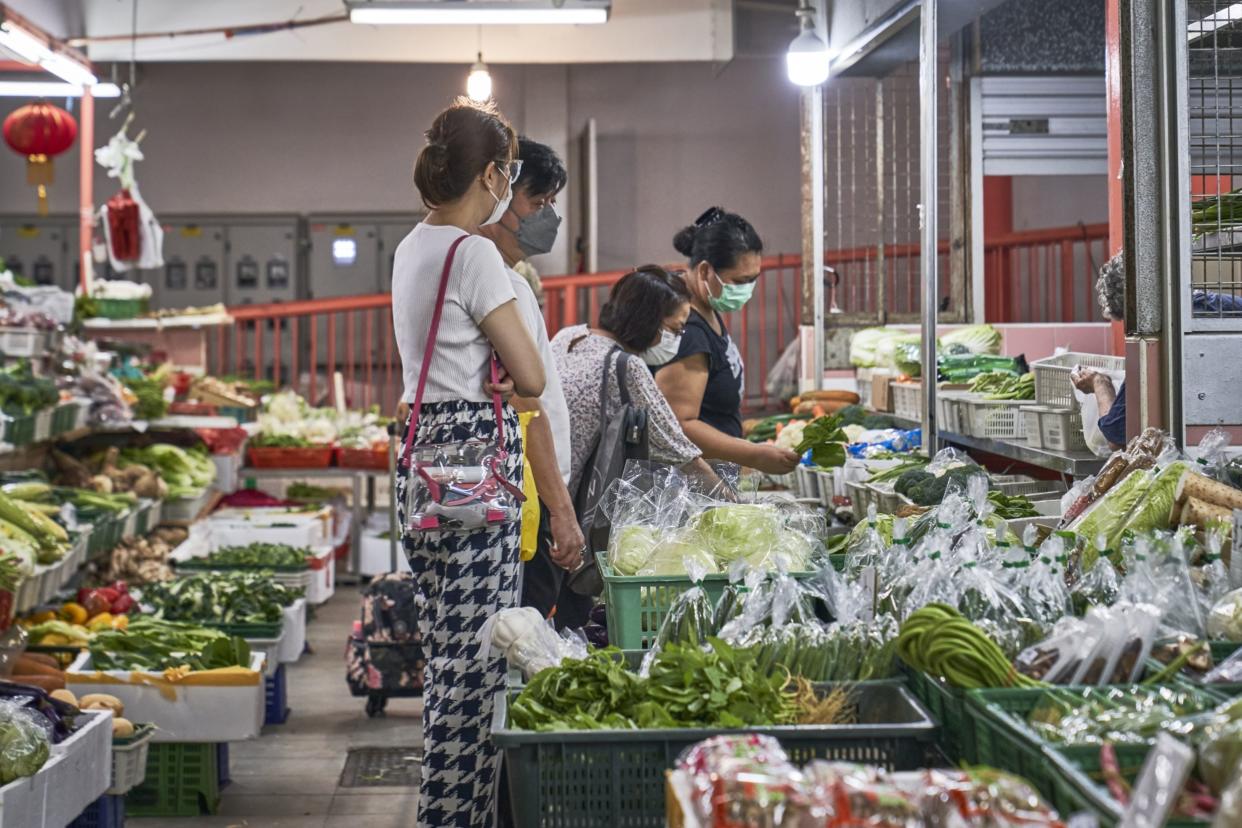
[492,682,935,828]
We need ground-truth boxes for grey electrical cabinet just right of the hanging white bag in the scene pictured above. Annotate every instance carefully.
[156,217,226,308]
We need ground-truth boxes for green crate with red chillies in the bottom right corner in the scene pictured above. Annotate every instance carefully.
[1045,745,1210,828]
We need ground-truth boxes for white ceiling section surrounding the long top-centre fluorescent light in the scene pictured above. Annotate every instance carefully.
[9,0,734,63]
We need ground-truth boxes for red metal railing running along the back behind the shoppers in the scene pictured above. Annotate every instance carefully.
[210,225,1108,411]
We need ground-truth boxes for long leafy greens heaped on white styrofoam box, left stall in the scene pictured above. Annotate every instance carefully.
[91,616,250,672]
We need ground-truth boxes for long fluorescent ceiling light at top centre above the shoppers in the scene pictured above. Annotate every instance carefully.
[349,0,611,26]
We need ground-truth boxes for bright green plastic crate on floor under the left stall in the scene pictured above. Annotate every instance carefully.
[125,742,220,817]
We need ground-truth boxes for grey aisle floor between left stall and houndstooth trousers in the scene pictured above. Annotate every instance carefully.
[125,586,422,828]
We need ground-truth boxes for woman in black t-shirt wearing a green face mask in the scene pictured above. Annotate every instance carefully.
[656,207,799,474]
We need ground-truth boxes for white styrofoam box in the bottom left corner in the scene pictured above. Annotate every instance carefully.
[0,710,112,828]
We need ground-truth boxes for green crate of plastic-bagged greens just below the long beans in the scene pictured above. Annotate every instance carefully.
[966,683,1220,798]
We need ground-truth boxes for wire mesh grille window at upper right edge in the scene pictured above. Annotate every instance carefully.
[1187,0,1242,330]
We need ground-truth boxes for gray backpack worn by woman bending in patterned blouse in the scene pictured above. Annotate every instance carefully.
[566,348,648,595]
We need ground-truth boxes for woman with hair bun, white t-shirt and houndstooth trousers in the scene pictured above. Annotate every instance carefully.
[392,99,544,828]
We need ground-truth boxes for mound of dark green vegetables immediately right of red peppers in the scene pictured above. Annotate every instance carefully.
[142,572,302,624]
